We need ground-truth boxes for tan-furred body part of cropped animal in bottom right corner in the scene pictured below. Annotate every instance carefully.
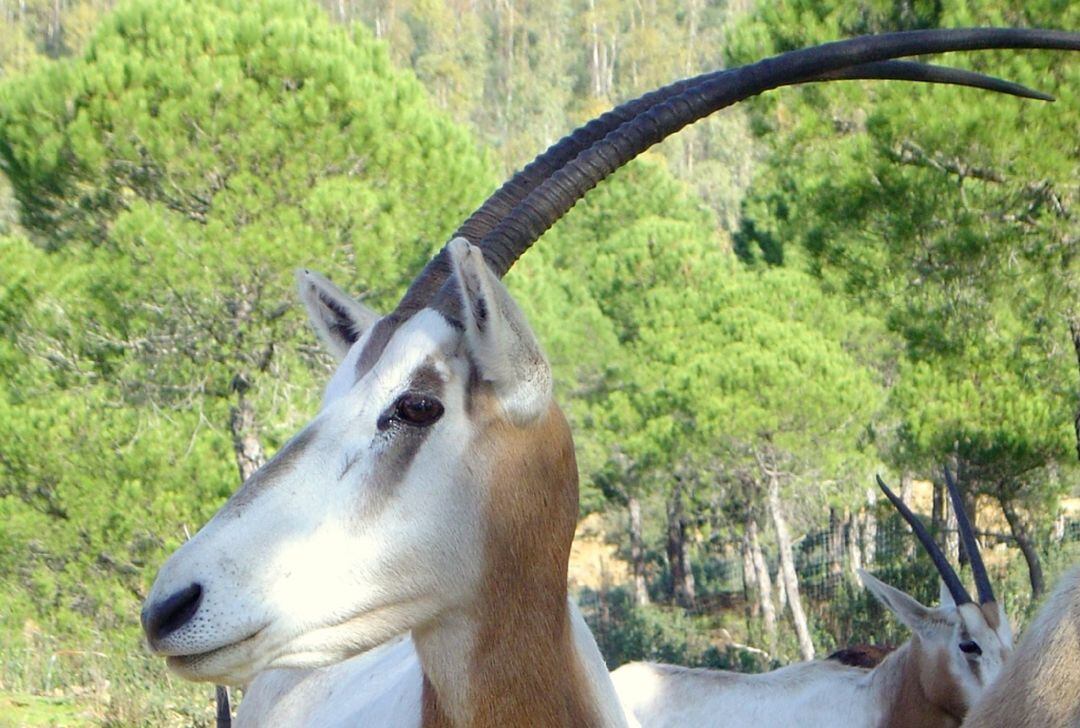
[963,569,1080,728]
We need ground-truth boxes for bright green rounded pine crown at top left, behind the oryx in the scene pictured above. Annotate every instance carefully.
[0,2,487,263]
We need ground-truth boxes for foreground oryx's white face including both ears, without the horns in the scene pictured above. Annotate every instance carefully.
[143,239,551,684]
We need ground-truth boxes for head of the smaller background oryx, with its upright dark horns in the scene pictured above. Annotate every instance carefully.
[860,469,1013,720]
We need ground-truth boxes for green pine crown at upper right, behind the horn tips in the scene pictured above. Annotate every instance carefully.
[729,1,1080,501]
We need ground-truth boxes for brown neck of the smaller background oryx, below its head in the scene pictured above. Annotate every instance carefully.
[874,635,967,728]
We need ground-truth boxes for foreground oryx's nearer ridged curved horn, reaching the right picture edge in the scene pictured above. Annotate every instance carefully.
[480,28,1080,275]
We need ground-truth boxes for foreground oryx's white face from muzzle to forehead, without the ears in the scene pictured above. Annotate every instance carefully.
[147,310,483,684]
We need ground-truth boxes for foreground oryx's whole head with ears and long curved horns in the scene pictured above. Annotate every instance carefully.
[143,30,1080,683]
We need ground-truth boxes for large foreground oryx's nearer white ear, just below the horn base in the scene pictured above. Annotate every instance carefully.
[447,238,552,424]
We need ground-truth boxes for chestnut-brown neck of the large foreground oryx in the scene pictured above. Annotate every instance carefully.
[414,405,600,727]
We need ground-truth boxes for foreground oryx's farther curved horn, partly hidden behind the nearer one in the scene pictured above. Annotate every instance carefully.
[397,49,1053,313]
